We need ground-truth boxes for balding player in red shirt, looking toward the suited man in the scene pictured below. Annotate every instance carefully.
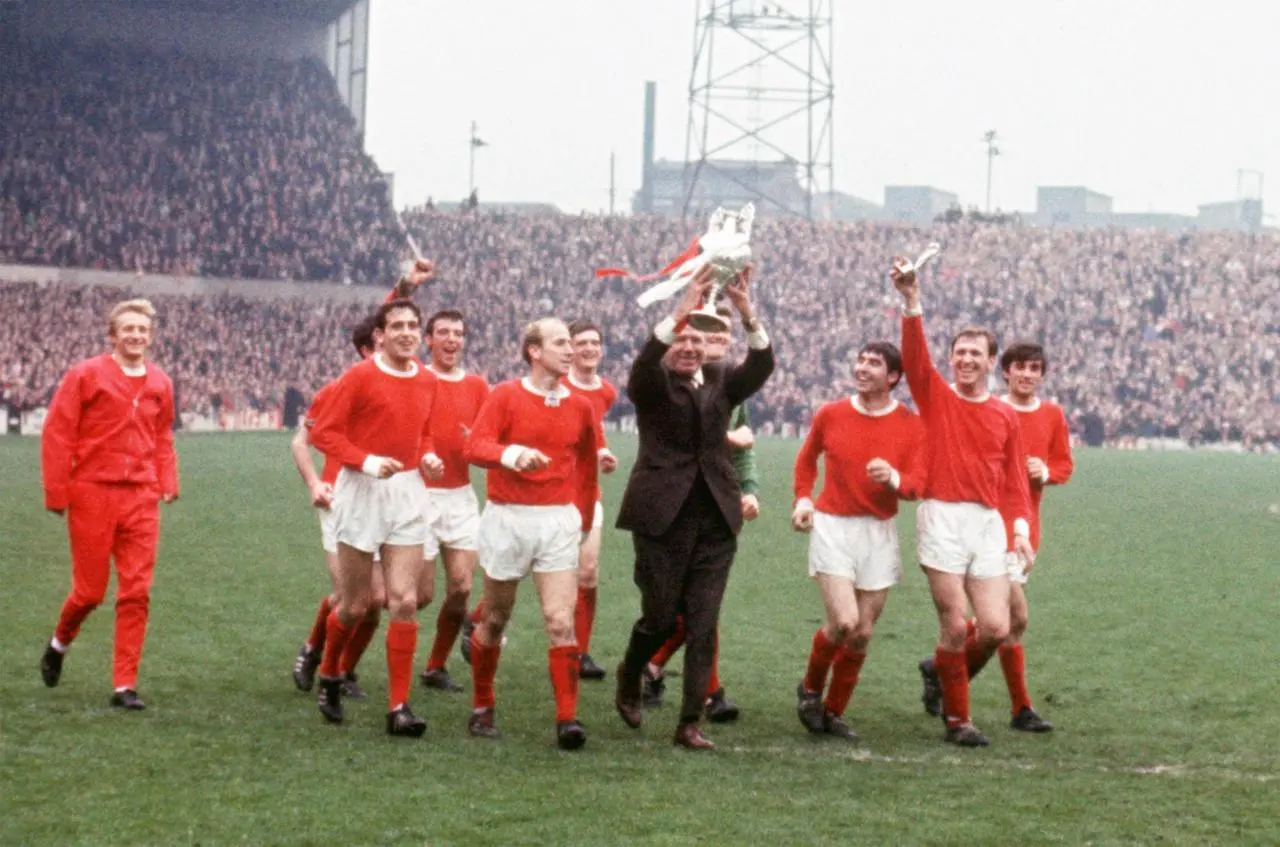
[466,317,600,750]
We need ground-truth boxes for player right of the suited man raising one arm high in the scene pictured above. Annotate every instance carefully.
[890,258,1036,747]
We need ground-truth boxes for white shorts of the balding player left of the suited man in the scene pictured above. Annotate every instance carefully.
[479,502,582,582]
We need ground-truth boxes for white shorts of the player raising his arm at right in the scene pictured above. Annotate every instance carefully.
[915,500,1009,580]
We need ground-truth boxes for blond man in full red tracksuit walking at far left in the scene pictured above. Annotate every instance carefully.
[40,299,178,709]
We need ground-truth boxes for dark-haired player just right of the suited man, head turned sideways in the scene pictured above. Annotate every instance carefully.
[791,342,924,740]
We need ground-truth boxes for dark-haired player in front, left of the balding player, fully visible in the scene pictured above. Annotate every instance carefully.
[311,299,444,737]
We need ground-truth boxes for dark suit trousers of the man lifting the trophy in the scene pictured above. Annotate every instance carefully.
[625,475,737,723]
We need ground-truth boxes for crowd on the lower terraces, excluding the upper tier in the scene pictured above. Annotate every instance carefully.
[0,210,1280,445]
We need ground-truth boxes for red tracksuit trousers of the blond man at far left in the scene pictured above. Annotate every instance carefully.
[54,482,160,688]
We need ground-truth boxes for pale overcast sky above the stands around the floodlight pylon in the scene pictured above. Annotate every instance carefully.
[367,0,1280,214]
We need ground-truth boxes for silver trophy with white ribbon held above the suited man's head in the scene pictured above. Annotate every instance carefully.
[636,203,755,333]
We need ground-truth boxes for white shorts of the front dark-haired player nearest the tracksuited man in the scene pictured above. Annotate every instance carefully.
[330,467,430,553]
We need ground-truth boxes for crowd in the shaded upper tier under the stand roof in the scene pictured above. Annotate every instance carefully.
[0,44,399,283]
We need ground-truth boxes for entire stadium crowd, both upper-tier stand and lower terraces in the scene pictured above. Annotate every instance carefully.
[0,45,1280,445]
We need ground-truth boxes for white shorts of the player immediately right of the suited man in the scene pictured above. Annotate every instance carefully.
[809,512,902,591]
